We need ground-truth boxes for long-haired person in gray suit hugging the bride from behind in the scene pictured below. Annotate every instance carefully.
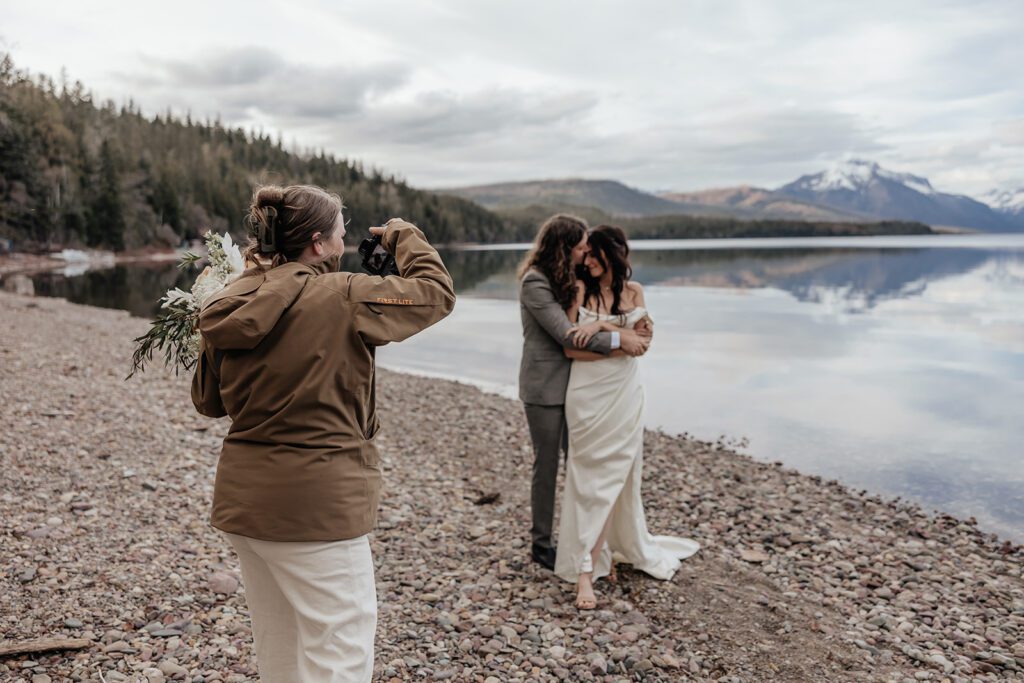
[518,214,651,569]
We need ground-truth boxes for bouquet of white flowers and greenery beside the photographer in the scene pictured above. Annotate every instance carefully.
[126,231,246,379]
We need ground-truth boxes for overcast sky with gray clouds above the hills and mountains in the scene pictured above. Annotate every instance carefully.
[0,0,1024,196]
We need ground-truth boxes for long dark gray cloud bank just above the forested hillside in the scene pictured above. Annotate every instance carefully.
[122,47,598,157]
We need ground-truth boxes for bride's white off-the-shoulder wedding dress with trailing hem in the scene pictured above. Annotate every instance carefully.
[555,307,700,583]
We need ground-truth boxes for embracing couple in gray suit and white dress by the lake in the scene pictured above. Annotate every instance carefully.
[519,215,699,609]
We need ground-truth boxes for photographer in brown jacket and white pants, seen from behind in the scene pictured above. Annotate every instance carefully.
[193,185,455,683]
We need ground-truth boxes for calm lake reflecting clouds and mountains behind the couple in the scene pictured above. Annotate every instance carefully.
[14,234,1024,542]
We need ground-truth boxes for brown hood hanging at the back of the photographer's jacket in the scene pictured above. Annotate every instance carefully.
[192,259,337,350]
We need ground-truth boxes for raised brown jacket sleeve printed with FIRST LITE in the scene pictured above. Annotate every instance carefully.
[348,221,455,346]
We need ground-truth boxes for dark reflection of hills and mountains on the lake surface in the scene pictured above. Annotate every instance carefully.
[18,239,1019,316]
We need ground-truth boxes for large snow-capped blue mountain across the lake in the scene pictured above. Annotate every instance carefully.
[776,159,1024,232]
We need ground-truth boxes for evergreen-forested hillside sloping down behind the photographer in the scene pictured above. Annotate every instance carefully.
[0,54,509,250]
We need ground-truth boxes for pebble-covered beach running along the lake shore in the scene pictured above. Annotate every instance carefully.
[0,294,1024,683]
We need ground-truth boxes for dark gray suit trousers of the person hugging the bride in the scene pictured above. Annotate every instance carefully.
[523,403,569,548]
